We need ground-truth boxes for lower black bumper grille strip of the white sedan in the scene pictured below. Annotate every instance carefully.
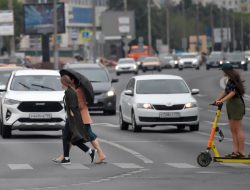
[139,116,198,122]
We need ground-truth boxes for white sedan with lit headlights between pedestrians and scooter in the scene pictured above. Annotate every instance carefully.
[119,75,199,132]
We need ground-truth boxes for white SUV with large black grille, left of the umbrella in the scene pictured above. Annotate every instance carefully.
[0,69,66,138]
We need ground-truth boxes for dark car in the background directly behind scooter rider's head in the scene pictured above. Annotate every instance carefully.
[226,51,248,71]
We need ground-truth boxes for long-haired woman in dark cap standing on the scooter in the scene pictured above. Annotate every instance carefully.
[216,63,245,158]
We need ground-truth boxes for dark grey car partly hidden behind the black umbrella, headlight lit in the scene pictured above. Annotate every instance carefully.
[64,63,118,115]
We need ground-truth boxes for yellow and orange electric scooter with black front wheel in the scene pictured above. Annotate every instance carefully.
[197,103,250,167]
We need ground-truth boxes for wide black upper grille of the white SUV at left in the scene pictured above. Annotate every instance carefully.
[17,102,63,112]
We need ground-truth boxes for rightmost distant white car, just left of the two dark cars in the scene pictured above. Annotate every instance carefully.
[178,53,201,70]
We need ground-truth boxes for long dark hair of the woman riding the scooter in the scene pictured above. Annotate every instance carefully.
[224,69,245,96]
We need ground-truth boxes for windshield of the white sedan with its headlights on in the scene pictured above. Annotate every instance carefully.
[136,79,189,94]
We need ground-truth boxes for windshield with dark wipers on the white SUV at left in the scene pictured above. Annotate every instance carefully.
[10,75,63,91]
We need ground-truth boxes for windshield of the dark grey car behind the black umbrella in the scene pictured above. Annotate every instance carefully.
[77,68,109,82]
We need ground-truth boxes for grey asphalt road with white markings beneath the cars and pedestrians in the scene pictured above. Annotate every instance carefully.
[0,64,250,190]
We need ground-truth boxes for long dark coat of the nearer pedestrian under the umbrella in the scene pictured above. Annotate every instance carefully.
[64,87,89,145]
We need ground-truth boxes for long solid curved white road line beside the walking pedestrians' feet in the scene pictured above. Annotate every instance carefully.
[100,139,154,164]
